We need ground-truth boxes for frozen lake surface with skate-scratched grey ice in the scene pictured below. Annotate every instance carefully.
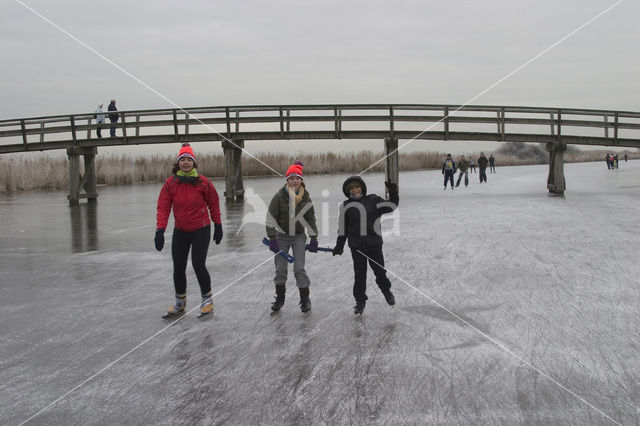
[0,161,640,425]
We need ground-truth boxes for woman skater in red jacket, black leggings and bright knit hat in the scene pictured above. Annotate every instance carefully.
[154,143,222,316]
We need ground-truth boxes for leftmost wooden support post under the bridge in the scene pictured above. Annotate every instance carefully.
[67,146,98,204]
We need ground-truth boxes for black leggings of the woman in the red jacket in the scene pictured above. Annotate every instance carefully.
[171,225,211,295]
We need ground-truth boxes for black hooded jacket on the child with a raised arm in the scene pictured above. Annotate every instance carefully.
[336,176,400,249]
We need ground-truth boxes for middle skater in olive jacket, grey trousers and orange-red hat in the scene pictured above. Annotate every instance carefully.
[265,161,318,312]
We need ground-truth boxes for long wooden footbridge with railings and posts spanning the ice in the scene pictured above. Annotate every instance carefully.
[0,104,640,203]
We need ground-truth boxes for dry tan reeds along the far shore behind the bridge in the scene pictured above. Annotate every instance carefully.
[0,150,640,193]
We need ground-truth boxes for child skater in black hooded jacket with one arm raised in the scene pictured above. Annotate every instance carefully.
[333,176,399,315]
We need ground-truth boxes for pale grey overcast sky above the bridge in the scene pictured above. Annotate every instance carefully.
[0,0,640,155]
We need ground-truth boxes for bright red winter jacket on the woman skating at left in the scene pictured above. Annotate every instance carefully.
[156,175,221,232]
